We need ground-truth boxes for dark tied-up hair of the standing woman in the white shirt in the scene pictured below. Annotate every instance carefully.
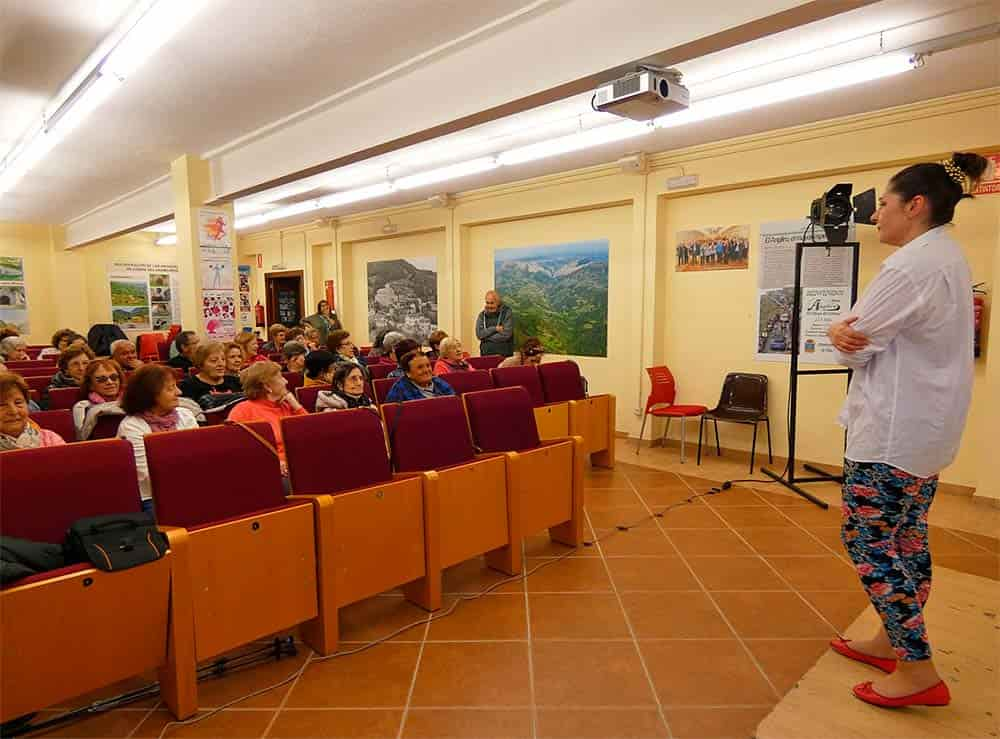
[887,152,989,227]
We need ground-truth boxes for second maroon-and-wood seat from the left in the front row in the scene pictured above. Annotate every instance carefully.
[145,423,336,661]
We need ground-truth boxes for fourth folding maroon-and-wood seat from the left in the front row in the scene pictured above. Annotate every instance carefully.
[382,395,520,574]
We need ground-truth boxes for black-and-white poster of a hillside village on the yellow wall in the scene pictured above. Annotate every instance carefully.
[367,257,437,345]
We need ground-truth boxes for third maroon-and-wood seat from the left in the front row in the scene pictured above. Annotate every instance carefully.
[281,408,441,648]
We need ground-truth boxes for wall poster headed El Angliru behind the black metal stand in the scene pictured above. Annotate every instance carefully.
[754,218,855,364]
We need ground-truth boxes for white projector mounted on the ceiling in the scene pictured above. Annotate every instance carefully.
[591,66,691,121]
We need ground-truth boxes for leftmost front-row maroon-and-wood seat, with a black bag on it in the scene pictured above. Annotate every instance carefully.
[0,439,197,722]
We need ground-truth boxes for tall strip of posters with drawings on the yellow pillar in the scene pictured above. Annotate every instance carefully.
[198,208,237,341]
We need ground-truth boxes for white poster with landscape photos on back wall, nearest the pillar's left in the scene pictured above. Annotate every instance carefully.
[108,262,181,333]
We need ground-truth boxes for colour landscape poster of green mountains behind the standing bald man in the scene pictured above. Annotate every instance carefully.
[493,239,611,357]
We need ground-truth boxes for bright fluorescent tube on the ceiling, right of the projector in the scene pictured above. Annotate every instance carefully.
[654,54,915,128]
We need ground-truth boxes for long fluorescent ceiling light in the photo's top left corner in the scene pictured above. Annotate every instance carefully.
[0,0,204,195]
